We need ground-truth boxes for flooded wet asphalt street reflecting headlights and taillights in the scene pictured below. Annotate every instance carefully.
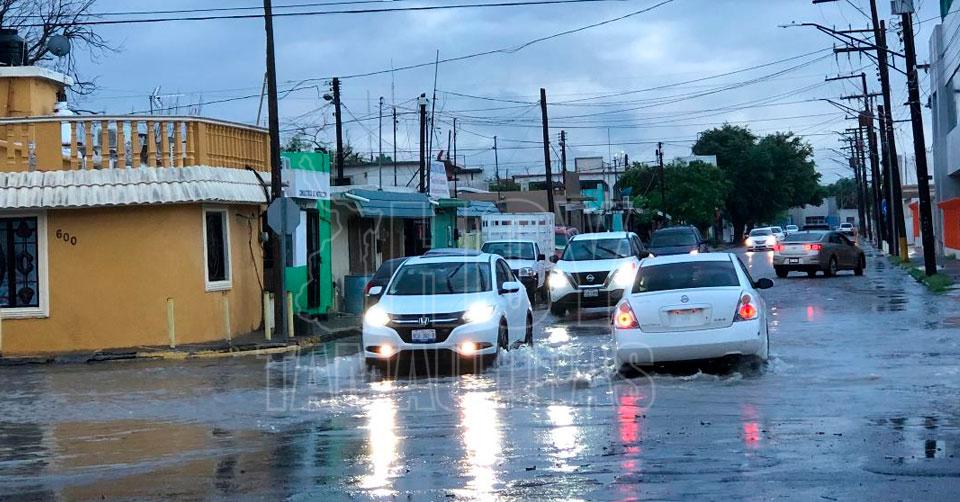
[0,249,960,500]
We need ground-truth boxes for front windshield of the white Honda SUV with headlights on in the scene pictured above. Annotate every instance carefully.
[387,262,490,296]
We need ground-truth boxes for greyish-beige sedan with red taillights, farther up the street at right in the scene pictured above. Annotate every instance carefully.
[773,230,867,277]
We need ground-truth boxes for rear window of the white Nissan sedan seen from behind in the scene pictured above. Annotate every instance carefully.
[633,261,740,293]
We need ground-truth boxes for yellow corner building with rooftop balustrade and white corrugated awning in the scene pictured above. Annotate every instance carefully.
[0,67,269,357]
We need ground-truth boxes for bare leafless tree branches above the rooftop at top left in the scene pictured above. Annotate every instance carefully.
[0,0,116,94]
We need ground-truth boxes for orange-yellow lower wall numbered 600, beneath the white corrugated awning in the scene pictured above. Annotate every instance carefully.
[2,204,263,356]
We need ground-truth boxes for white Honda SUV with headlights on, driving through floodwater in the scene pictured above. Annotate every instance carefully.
[361,253,533,369]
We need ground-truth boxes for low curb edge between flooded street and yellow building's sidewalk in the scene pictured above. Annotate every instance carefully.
[0,328,360,367]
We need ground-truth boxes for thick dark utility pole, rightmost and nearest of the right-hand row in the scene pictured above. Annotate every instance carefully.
[900,2,937,276]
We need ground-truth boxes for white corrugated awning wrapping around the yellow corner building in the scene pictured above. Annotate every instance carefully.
[0,166,266,209]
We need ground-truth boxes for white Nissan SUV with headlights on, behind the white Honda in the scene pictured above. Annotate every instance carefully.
[547,232,650,316]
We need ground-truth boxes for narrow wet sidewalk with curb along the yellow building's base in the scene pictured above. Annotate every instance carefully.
[0,314,360,366]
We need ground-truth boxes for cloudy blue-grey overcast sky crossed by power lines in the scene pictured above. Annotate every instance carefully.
[74,0,939,181]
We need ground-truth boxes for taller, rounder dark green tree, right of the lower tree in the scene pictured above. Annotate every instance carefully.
[693,124,823,234]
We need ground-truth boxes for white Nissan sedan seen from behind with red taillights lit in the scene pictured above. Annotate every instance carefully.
[613,253,773,369]
